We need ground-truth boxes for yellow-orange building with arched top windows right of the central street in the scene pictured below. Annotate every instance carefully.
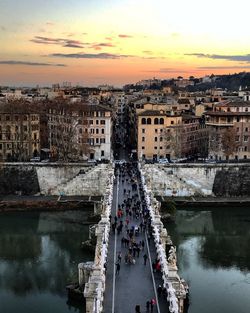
[136,104,207,160]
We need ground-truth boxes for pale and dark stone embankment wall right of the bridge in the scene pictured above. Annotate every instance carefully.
[143,163,250,197]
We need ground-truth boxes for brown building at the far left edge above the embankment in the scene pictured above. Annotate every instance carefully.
[0,102,41,161]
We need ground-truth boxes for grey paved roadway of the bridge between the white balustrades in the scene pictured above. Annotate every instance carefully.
[104,163,168,313]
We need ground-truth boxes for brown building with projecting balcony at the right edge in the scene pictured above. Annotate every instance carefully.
[206,101,250,160]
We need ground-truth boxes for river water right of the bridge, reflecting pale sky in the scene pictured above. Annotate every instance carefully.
[166,208,250,313]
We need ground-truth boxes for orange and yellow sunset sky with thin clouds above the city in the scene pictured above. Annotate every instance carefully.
[0,0,250,86]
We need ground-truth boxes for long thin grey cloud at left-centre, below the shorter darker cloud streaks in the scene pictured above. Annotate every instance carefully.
[49,52,132,59]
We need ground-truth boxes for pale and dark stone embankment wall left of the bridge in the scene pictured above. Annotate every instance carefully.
[0,163,112,196]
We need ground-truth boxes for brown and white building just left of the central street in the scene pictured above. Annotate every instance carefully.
[48,101,112,161]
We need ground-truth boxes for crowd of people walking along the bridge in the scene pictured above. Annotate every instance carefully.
[109,162,165,313]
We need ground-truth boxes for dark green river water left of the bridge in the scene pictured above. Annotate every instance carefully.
[0,211,93,313]
